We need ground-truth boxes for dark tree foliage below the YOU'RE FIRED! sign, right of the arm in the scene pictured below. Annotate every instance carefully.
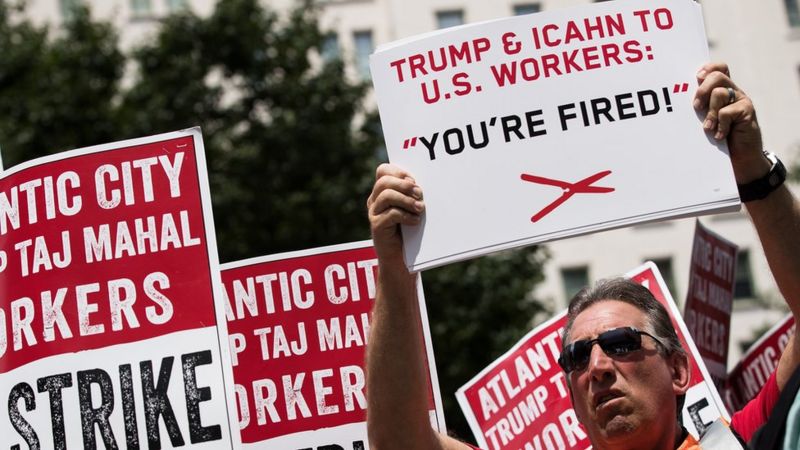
[422,247,546,438]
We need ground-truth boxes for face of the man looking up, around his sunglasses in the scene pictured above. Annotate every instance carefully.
[568,300,688,448]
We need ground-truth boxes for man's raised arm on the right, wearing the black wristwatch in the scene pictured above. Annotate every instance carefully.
[695,63,800,389]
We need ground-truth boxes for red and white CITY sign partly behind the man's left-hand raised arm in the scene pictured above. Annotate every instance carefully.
[222,241,445,450]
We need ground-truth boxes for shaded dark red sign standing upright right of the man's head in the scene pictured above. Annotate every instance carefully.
[684,220,738,386]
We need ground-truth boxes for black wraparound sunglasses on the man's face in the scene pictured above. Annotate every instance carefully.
[558,327,663,373]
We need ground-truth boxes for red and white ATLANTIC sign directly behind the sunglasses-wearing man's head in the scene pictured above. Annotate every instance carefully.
[456,262,730,450]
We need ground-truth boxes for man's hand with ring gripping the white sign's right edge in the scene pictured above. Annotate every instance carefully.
[694,63,771,184]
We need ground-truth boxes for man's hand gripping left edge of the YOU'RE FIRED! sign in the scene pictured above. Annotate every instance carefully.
[367,164,425,263]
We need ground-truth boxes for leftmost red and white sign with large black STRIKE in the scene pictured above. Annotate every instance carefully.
[0,128,239,449]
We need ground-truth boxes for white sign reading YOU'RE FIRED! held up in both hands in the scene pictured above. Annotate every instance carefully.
[371,0,739,270]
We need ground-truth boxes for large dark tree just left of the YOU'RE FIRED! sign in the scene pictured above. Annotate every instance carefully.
[121,0,378,260]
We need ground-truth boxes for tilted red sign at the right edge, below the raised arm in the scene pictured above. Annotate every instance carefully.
[723,314,795,411]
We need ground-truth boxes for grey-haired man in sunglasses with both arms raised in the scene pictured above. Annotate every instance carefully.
[367,64,800,450]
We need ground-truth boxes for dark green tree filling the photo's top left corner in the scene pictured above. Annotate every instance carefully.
[0,1,125,166]
